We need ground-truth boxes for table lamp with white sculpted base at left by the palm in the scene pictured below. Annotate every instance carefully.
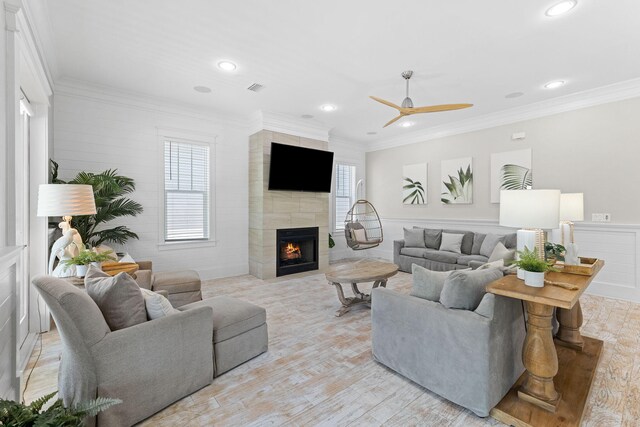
[37,184,96,277]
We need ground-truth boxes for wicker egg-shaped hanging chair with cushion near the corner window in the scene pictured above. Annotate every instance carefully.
[344,199,382,251]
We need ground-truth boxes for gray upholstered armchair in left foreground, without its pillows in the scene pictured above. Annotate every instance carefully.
[33,276,214,426]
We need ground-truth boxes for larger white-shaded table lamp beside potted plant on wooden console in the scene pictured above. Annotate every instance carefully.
[500,190,560,279]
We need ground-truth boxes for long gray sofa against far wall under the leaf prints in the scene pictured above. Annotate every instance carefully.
[393,227,516,273]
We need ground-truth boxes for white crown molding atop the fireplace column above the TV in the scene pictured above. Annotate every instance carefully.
[249,110,329,141]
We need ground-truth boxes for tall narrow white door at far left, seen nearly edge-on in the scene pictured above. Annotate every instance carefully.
[15,94,33,349]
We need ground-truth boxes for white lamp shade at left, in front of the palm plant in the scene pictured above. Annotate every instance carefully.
[38,184,96,216]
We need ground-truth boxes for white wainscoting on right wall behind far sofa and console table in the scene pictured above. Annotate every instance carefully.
[368,218,640,302]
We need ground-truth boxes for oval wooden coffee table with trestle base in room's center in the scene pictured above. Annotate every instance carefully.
[325,258,398,316]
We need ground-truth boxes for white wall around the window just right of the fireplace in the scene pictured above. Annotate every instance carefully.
[329,137,367,261]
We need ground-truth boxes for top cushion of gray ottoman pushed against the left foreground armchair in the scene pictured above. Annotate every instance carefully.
[179,296,267,344]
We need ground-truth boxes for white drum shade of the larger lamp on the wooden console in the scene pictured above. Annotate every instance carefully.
[500,190,560,229]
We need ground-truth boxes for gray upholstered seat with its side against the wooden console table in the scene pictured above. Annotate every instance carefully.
[371,271,525,417]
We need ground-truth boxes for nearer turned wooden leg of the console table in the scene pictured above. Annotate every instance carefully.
[518,301,560,412]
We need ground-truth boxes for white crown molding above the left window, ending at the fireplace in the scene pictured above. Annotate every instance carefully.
[55,78,248,130]
